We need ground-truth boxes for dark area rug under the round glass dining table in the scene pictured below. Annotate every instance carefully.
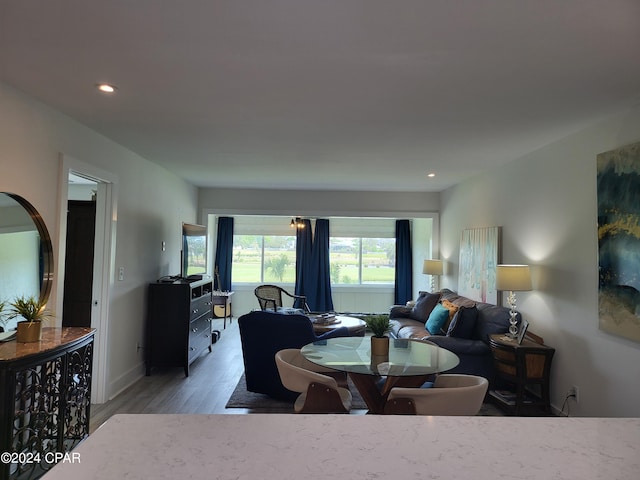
[226,374,504,416]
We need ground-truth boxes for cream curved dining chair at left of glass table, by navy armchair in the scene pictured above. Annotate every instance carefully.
[275,348,352,413]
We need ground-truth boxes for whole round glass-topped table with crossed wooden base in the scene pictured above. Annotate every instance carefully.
[300,336,460,413]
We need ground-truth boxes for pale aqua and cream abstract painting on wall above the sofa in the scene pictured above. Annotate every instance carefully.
[458,227,501,305]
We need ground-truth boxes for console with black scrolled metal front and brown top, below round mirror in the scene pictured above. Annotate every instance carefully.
[0,327,94,480]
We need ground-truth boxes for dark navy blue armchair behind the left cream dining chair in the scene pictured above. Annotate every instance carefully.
[238,311,349,401]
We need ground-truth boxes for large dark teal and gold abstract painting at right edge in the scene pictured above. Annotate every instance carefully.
[597,143,640,342]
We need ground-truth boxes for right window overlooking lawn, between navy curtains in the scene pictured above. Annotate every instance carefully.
[329,237,396,285]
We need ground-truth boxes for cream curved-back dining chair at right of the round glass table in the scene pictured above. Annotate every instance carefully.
[384,374,489,415]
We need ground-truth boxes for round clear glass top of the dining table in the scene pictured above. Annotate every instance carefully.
[301,337,460,377]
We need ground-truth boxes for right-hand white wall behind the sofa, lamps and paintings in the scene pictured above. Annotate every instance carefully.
[440,107,640,417]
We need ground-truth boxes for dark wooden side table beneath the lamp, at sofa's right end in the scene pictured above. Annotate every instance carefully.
[489,334,555,415]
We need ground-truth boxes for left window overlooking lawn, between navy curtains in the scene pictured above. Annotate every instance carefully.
[231,235,296,283]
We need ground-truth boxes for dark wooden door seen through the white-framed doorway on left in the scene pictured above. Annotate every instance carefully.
[62,200,96,327]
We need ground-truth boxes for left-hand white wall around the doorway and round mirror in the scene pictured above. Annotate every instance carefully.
[0,83,197,402]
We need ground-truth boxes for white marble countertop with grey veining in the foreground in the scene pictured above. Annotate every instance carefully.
[44,414,640,480]
